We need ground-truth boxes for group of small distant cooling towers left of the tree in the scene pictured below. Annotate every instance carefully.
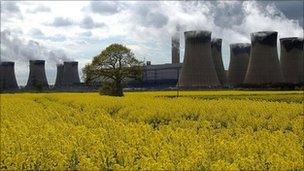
[0,60,81,90]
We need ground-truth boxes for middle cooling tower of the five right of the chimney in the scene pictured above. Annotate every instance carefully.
[228,43,250,86]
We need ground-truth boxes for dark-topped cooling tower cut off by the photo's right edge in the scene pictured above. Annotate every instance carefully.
[280,37,304,84]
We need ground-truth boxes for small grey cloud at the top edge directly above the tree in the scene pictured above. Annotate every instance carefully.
[89,1,121,15]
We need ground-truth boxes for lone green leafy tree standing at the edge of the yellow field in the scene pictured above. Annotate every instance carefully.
[83,44,142,96]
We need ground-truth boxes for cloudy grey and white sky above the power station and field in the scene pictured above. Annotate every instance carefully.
[1,1,304,85]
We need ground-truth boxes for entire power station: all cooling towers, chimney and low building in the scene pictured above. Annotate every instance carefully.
[0,31,304,90]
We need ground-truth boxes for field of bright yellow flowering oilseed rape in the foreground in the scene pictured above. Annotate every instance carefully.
[0,91,304,170]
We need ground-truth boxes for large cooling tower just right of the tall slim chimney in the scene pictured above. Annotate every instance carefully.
[178,31,220,88]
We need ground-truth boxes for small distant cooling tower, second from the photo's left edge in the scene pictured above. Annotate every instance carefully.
[26,60,49,89]
